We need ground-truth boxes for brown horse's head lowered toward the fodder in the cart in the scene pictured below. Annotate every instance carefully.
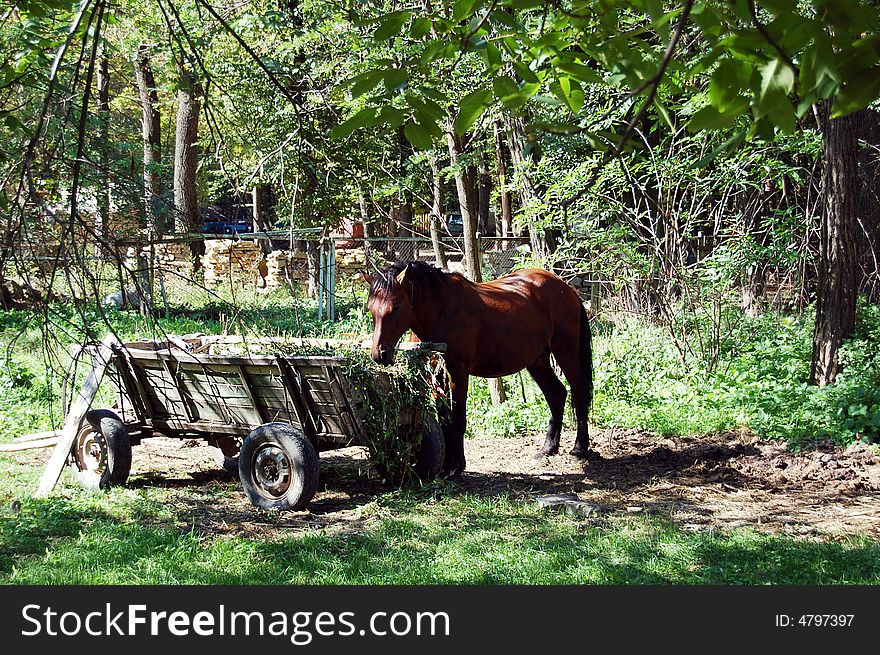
[364,264,415,365]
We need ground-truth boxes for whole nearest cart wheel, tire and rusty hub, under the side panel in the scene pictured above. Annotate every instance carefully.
[238,423,318,510]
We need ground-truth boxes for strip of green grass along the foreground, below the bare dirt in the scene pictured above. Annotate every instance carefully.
[0,490,880,584]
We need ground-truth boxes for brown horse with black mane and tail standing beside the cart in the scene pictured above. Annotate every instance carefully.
[364,262,593,477]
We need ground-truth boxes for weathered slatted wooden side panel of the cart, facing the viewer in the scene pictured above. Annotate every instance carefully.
[107,348,365,449]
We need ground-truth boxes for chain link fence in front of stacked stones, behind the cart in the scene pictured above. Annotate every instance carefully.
[6,229,597,320]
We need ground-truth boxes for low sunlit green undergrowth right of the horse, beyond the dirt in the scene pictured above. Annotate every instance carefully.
[594,306,880,447]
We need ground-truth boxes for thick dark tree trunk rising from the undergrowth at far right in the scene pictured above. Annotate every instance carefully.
[810,106,864,386]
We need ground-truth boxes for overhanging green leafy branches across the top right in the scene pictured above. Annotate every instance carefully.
[358,0,880,138]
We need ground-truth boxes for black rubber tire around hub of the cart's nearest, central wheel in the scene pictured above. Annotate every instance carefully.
[238,423,319,511]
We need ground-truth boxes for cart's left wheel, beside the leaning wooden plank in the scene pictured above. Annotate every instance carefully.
[71,409,131,489]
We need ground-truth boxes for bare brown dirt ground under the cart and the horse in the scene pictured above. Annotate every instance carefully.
[98,429,880,538]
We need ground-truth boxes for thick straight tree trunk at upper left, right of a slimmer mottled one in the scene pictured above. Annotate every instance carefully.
[174,68,205,269]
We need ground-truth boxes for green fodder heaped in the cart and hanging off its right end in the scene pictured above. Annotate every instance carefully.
[203,339,448,485]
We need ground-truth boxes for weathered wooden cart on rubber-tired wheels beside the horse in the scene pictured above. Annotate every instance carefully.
[34,336,445,510]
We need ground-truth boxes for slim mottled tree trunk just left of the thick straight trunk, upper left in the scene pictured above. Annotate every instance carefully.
[135,43,165,236]
